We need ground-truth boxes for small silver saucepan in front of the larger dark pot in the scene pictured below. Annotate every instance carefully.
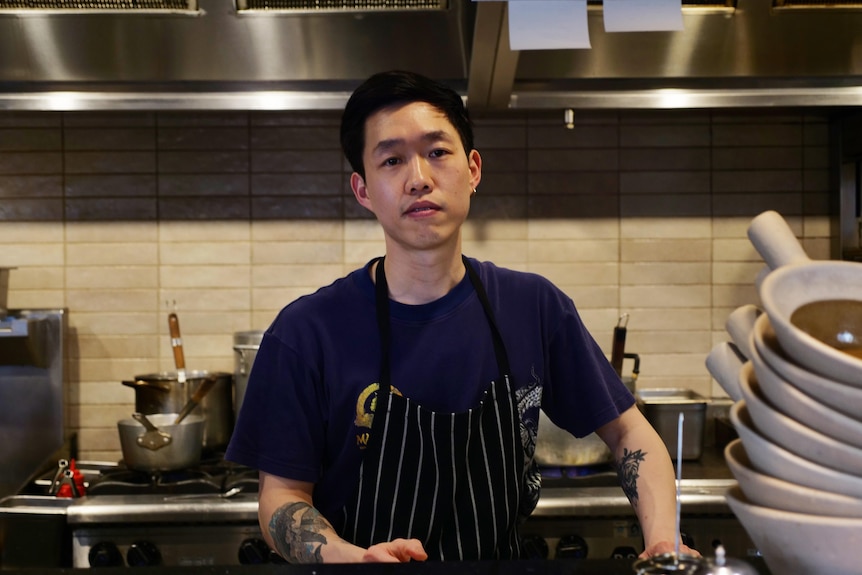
[117,413,204,472]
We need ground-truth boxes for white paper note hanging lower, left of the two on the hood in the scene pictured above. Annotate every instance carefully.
[509,0,590,50]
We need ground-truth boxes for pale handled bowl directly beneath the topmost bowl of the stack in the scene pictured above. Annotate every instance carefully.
[752,315,862,419]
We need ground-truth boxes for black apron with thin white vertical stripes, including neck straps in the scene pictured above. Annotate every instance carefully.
[341,258,524,560]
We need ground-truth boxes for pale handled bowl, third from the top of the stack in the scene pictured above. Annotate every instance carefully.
[751,324,862,449]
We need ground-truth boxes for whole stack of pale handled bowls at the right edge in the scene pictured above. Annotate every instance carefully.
[712,212,862,575]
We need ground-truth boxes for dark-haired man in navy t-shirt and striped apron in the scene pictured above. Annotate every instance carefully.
[226,72,690,562]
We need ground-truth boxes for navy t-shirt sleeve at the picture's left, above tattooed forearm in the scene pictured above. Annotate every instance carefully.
[225,331,325,482]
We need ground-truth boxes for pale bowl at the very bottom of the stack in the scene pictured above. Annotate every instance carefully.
[727,486,862,575]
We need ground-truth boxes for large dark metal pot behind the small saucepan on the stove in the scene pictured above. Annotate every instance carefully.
[123,370,234,451]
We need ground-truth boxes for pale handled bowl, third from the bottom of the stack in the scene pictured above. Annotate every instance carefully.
[730,400,862,498]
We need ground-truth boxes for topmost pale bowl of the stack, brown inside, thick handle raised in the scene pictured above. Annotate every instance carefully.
[748,211,862,384]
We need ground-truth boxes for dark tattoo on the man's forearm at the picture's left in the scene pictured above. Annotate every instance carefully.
[269,501,332,563]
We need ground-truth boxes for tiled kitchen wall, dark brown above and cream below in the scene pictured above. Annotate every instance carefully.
[0,110,834,460]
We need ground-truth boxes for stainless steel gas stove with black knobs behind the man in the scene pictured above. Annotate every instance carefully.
[0,448,756,568]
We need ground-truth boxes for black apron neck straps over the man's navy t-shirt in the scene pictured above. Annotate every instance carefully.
[374,255,511,396]
